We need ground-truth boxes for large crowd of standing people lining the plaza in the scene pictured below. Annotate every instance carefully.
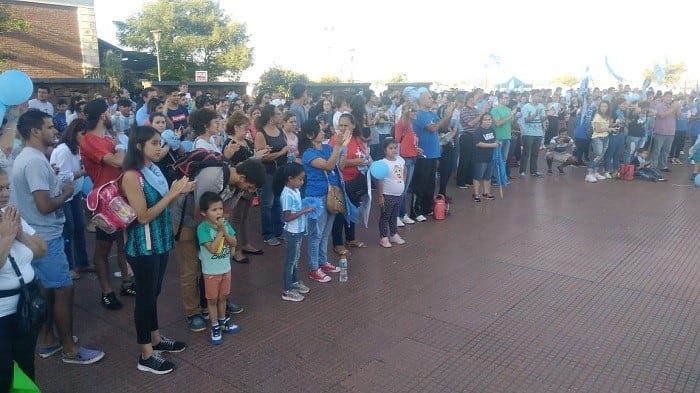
[0,82,700,391]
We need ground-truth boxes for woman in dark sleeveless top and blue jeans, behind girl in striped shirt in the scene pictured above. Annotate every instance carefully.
[255,104,289,246]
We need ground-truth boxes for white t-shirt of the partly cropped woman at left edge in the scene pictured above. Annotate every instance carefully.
[0,217,34,318]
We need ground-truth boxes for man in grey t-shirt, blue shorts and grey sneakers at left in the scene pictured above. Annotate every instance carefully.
[10,110,105,364]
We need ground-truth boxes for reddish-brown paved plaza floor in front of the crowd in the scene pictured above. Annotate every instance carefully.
[36,166,700,392]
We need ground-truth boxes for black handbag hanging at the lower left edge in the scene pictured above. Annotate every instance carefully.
[0,255,48,333]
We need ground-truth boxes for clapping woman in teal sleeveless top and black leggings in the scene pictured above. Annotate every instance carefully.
[121,126,194,374]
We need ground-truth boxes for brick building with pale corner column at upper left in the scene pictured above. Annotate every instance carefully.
[2,0,100,79]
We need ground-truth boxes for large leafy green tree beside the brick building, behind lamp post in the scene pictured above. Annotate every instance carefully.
[115,0,253,80]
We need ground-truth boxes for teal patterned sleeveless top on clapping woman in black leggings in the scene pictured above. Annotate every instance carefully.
[124,175,174,257]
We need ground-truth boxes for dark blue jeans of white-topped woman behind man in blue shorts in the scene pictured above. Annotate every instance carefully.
[63,195,90,269]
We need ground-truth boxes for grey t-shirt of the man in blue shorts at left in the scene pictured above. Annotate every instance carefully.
[10,146,66,241]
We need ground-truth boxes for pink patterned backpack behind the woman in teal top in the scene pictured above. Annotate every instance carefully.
[87,173,143,234]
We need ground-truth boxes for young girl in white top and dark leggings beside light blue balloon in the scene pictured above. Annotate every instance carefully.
[377,138,406,248]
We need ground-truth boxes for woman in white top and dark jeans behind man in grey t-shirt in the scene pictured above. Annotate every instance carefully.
[49,118,94,280]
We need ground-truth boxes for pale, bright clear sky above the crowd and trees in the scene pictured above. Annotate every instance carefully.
[94,0,700,87]
